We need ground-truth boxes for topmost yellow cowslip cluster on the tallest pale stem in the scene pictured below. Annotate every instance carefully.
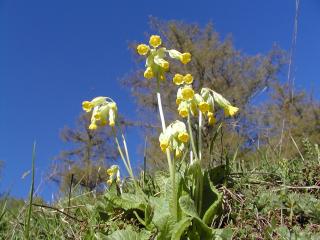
[137,35,191,81]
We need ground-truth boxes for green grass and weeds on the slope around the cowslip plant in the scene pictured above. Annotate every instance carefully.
[0,139,320,239]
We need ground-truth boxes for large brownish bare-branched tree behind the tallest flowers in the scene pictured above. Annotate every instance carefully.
[124,18,285,167]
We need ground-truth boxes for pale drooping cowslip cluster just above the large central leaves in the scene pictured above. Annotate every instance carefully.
[159,120,189,158]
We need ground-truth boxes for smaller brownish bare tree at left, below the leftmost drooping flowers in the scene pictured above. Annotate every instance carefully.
[50,114,118,192]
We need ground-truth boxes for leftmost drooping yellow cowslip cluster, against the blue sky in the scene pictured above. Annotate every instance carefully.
[82,97,118,130]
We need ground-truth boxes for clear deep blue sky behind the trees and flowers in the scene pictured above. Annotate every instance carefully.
[0,0,320,202]
